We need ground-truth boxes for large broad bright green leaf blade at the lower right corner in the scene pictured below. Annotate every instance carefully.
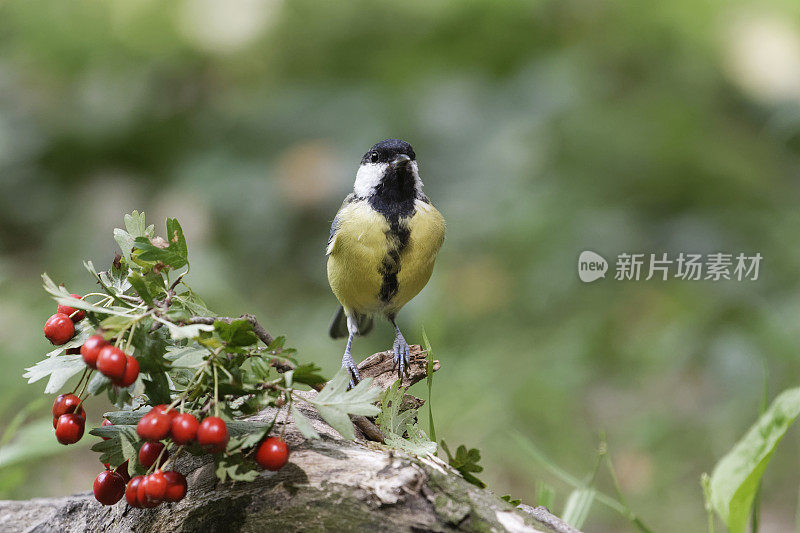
[709,387,800,533]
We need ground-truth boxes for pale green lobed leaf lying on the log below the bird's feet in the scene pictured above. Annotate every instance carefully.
[308,368,380,440]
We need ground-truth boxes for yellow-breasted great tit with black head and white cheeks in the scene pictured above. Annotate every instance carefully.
[327,139,445,384]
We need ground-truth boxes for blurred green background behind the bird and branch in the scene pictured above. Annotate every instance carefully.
[0,0,800,531]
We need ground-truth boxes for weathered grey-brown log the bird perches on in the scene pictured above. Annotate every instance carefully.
[0,346,578,533]
